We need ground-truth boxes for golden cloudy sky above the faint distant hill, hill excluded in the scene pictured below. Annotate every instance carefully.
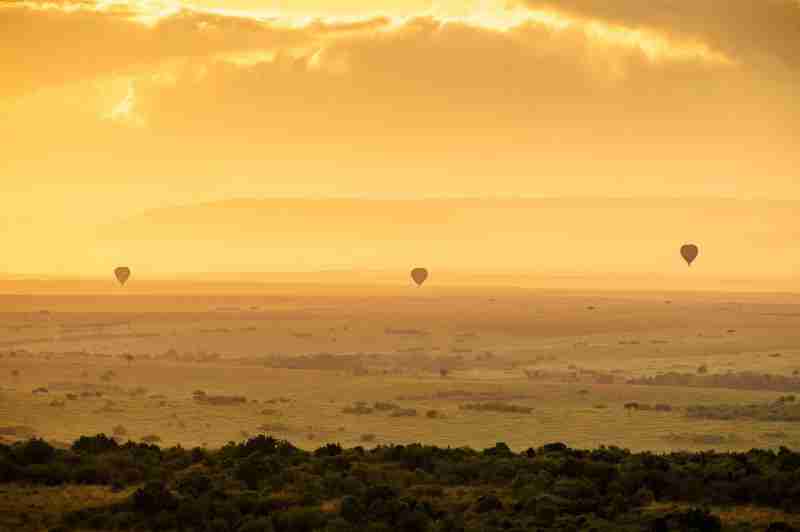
[0,0,800,272]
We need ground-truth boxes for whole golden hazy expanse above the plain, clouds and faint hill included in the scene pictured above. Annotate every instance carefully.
[0,0,800,278]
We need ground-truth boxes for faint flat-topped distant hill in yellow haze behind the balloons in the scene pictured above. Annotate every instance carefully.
[98,199,800,278]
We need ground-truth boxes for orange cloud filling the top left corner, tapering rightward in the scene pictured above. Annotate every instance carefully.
[0,1,385,98]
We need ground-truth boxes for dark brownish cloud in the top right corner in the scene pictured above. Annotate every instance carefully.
[524,0,800,70]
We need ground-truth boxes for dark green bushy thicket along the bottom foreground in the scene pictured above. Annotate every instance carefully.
[0,435,800,532]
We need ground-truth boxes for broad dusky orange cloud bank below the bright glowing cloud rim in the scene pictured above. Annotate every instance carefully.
[134,18,789,150]
